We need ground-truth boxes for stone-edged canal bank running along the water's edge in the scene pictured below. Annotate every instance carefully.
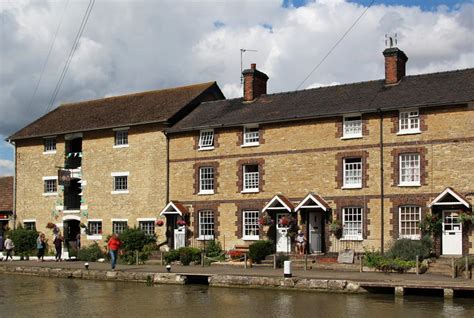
[0,261,474,298]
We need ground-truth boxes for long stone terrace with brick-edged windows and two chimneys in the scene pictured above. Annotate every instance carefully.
[161,48,474,255]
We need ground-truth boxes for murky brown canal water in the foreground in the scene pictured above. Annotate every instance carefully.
[0,275,474,318]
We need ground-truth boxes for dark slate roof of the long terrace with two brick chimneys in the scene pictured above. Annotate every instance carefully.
[168,68,474,132]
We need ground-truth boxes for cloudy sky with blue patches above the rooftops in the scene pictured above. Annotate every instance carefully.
[0,0,474,176]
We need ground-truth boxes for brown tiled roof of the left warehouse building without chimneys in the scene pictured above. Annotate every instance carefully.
[9,82,224,140]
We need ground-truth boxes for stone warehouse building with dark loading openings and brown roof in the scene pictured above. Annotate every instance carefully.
[9,82,224,256]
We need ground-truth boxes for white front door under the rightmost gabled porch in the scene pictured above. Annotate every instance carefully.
[442,211,462,255]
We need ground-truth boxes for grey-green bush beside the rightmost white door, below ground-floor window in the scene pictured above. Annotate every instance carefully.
[387,236,433,261]
